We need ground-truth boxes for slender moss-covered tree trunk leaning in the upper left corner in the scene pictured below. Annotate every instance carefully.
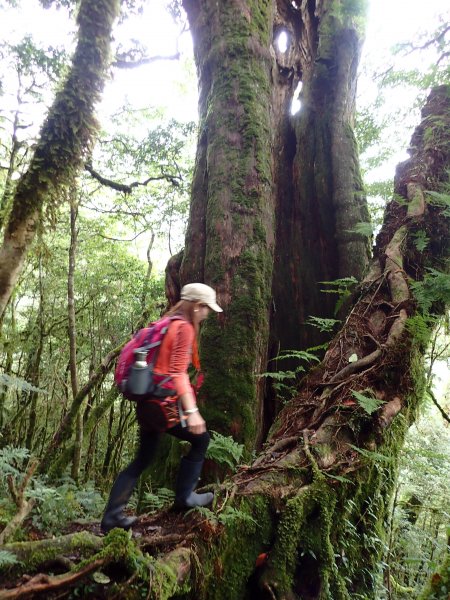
[0,0,119,316]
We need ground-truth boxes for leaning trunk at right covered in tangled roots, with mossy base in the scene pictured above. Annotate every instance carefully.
[0,86,450,600]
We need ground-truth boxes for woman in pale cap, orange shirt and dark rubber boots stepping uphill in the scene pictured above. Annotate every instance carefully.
[101,283,222,533]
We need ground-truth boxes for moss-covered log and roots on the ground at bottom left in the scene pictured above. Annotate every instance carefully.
[0,530,195,600]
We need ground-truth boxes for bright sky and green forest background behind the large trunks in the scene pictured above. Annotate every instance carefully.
[0,2,450,598]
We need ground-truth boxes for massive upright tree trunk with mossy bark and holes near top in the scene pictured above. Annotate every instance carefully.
[178,0,368,448]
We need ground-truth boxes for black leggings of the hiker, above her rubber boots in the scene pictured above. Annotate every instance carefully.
[122,425,209,478]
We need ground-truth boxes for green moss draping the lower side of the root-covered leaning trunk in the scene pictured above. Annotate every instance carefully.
[264,350,423,600]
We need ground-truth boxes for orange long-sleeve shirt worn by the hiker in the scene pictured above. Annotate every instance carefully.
[154,319,195,396]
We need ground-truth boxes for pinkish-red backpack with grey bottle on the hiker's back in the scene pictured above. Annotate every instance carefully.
[114,316,184,431]
